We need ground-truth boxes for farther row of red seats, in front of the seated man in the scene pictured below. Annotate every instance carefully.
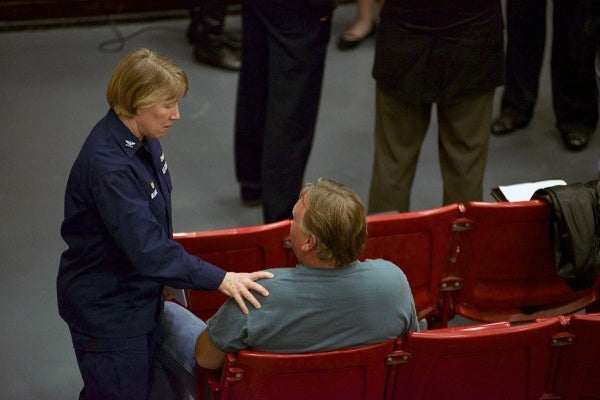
[175,200,600,327]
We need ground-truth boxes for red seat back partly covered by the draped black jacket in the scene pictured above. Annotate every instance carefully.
[453,200,598,321]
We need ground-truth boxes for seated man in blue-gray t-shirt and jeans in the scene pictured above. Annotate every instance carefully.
[152,179,419,393]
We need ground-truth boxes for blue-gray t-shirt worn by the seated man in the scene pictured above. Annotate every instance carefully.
[207,259,419,353]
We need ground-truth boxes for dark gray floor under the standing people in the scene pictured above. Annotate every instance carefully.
[0,5,600,400]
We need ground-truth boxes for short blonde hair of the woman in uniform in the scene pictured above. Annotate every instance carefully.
[106,49,188,117]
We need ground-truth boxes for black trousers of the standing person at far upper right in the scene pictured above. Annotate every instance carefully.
[492,0,598,149]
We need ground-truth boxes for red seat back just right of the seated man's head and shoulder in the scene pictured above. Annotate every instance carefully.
[360,204,462,319]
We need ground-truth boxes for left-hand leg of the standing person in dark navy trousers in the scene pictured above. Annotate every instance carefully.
[234,1,269,205]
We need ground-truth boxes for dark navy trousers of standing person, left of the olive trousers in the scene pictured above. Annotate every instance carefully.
[235,0,331,223]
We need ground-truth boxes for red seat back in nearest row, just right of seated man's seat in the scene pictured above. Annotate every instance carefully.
[386,317,560,400]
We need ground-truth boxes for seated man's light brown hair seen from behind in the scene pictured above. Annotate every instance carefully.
[300,178,367,267]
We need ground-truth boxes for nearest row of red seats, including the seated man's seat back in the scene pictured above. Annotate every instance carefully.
[196,314,600,400]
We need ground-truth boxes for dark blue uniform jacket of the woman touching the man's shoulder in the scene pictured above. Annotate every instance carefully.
[57,110,225,338]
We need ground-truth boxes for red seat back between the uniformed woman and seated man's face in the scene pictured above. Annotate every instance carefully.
[174,220,295,321]
